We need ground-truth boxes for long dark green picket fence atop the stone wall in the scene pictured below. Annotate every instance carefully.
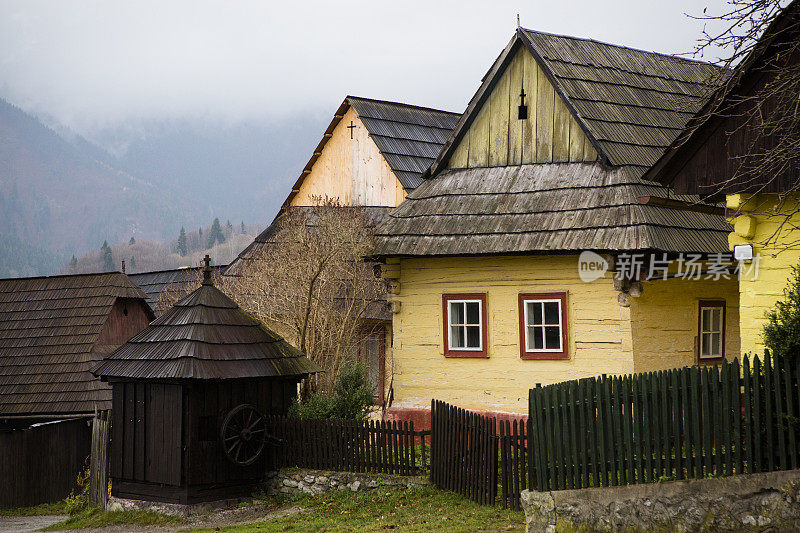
[528,355,800,490]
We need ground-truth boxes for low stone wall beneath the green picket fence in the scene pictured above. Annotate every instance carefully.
[521,470,800,532]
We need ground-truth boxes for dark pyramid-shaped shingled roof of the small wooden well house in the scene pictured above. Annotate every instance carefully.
[94,262,320,379]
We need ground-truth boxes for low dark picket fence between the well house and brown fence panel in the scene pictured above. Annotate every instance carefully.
[268,416,430,476]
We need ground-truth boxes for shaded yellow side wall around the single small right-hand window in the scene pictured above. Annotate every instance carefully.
[630,279,740,372]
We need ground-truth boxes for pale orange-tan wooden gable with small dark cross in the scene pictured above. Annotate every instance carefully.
[291,107,406,207]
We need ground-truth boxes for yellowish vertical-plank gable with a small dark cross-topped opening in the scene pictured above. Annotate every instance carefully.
[448,49,597,168]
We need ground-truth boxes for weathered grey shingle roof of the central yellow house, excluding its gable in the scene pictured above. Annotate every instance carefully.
[376,29,730,256]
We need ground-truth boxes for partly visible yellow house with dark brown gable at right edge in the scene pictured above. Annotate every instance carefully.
[646,1,800,354]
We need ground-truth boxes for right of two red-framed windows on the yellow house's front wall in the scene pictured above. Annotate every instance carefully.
[519,292,569,359]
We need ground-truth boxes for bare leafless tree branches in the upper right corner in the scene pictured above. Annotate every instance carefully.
[695,0,800,224]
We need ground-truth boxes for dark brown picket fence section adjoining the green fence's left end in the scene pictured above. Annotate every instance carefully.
[431,400,498,505]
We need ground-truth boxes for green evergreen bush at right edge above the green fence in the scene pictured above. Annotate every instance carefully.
[764,266,800,361]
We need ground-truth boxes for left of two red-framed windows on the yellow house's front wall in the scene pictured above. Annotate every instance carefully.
[442,294,486,357]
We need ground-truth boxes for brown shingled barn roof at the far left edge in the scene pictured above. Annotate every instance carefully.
[0,272,146,417]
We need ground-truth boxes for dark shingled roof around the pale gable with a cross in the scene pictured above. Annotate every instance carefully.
[281,96,461,210]
